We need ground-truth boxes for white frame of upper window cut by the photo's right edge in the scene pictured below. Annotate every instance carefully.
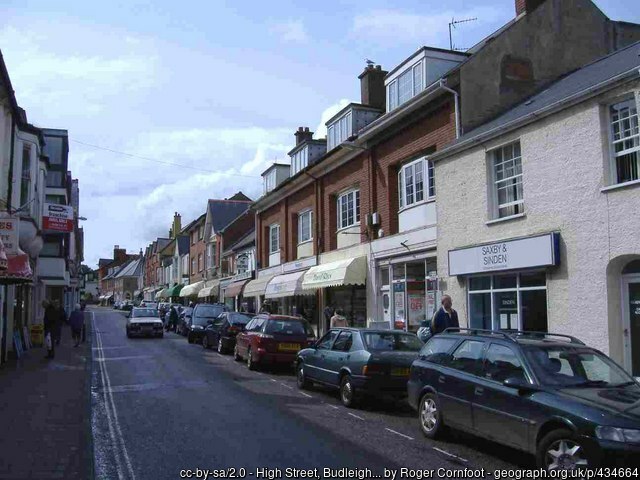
[607,96,640,185]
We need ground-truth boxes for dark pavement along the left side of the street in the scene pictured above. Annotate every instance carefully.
[0,316,93,480]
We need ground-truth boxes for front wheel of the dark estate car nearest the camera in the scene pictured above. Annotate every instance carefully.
[536,429,594,470]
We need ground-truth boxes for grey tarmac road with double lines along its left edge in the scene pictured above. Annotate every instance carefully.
[90,308,532,479]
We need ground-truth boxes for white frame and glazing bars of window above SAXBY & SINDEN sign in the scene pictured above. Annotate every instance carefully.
[487,139,524,219]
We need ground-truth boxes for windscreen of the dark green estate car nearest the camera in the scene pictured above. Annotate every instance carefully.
[523,345,633,387]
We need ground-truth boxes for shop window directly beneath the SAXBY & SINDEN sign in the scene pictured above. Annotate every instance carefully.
[468,271,547,332]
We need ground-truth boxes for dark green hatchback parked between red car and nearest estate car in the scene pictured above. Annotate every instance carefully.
[296,328,424,407]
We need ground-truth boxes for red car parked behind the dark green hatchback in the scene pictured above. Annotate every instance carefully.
[233,314,315,370]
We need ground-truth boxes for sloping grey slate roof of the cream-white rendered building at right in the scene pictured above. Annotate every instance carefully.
[433,42,640,158]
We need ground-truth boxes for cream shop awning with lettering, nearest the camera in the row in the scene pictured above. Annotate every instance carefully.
[302,257,367,290]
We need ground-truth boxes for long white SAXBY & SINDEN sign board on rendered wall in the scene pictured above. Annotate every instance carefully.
[449,233,560,276]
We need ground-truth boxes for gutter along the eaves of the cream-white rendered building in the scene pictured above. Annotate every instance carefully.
[431,67,640,160]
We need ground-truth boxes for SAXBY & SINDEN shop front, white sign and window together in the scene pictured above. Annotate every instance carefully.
[449,233,560,332]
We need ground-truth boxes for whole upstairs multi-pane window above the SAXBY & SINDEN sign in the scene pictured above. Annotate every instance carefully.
[489,142,524,218]
